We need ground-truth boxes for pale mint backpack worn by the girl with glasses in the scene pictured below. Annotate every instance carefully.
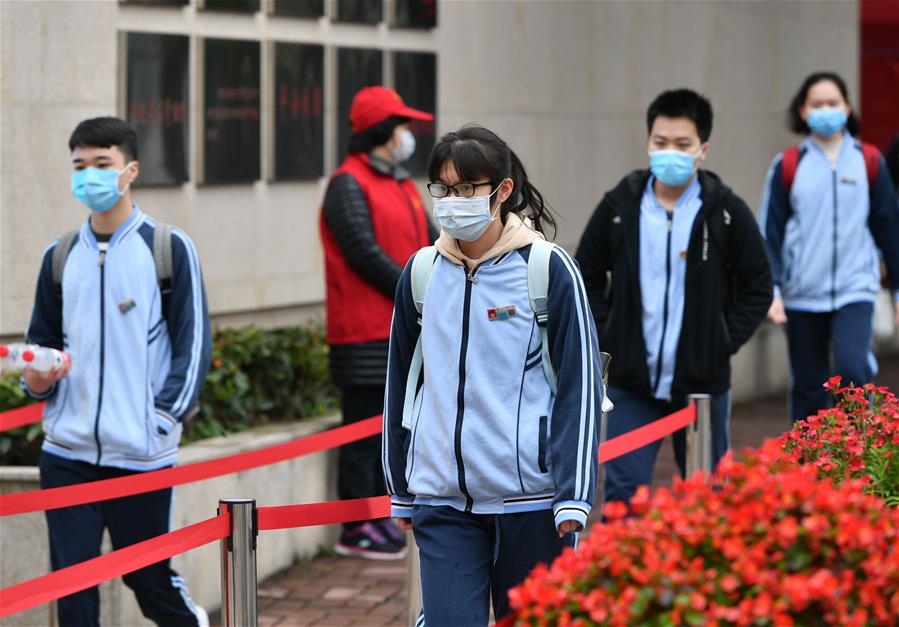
[403,239,612,429]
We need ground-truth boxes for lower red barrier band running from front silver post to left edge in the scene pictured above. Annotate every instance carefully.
[0,513,231,618]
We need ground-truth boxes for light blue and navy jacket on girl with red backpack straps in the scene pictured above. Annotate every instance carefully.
[759,133,899,313]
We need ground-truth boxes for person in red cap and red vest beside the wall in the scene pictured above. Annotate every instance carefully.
[319,86,437,559]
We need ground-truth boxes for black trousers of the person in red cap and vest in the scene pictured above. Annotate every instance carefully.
[337,385,387,500]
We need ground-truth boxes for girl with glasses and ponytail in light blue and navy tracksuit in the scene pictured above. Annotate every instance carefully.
[383,126,603,627]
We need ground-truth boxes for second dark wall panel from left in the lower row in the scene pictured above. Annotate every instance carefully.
[203,39,260,183]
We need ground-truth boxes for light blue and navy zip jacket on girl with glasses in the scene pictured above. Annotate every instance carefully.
[382,246,603,526]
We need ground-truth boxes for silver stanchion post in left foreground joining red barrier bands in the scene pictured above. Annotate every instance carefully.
[218,499,259,627]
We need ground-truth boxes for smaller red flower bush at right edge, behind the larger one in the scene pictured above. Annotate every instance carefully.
[780,377,899,508]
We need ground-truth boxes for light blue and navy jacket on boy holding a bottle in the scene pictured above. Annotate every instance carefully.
[28,207,212,470]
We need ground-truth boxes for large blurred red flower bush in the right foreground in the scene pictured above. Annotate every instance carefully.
[510,441,899,626]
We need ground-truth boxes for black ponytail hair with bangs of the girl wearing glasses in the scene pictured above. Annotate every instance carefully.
[428,124,556,237]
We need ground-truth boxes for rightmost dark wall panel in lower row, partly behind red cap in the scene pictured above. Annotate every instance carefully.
[393,52,437,176]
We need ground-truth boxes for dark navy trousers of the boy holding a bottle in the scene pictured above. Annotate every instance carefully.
[39,452,198,627]
